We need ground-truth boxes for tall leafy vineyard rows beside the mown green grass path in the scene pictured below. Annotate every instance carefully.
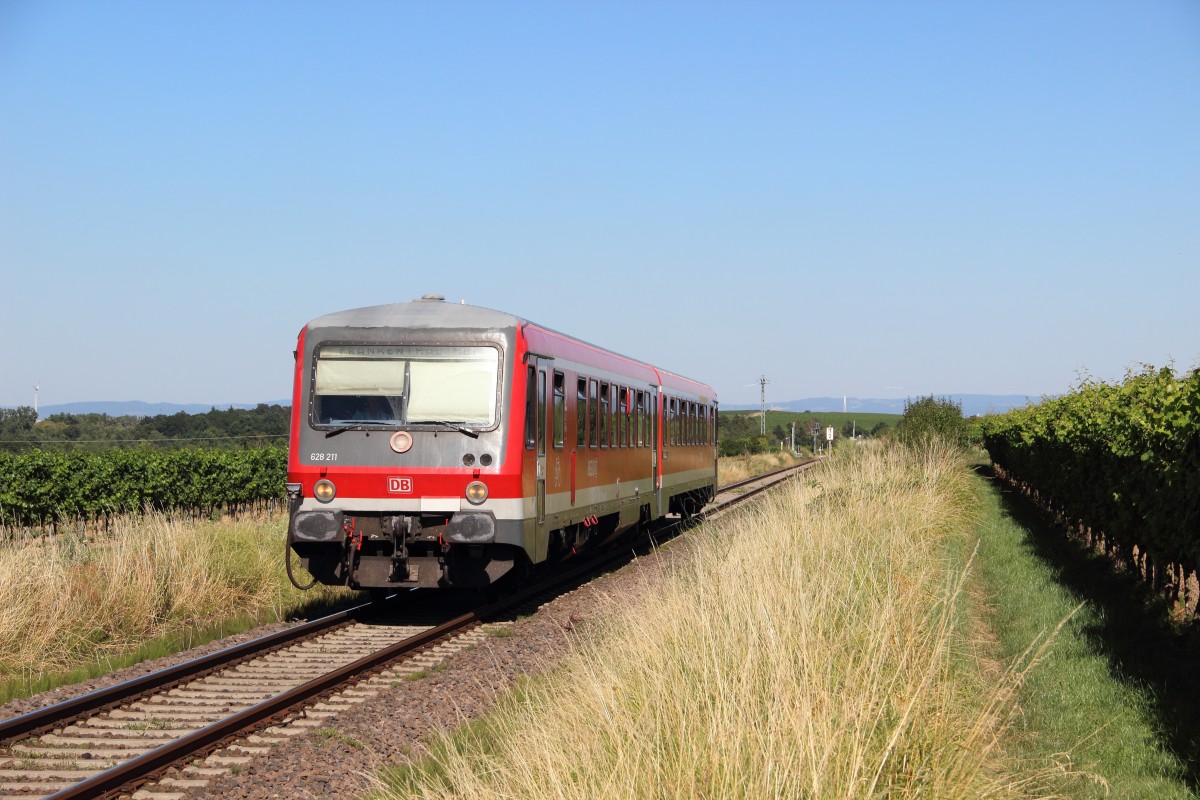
[983,367,1200,618]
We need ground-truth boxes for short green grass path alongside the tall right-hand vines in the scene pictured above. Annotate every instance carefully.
[977,465,1200,800]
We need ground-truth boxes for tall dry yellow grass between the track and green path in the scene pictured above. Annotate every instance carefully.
[383,446,1060,800]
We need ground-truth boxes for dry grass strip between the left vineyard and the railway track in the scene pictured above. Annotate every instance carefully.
[0,513,348,702]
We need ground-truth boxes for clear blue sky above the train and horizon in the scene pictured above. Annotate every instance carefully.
[0,0,1200,405]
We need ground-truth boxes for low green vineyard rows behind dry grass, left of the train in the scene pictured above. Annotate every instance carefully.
[0,447,288,537]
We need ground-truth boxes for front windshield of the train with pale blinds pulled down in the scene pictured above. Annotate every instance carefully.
[312,344,500,428]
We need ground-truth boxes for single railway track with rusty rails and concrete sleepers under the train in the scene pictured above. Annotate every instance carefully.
[0,462,812,800]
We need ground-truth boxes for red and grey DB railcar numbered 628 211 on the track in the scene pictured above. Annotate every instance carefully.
[288,295,716,589]
